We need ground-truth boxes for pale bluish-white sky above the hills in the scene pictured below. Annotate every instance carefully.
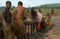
[0,0,60,7]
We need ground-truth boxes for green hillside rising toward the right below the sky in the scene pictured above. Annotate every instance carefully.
[32,3,60,9]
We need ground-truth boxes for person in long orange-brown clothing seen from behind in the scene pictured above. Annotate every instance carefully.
[12,1,27,39]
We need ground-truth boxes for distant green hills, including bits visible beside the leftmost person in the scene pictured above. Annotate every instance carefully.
[0,3,60,10]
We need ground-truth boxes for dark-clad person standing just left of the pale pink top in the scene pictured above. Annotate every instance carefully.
[30,9,37,33]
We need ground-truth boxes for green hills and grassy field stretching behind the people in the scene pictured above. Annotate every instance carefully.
[0,3,60,16]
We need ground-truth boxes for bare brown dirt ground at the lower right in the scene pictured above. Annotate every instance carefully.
[0,16,60,39]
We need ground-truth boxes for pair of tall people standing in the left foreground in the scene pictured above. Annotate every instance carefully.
[2,1,27,39]
